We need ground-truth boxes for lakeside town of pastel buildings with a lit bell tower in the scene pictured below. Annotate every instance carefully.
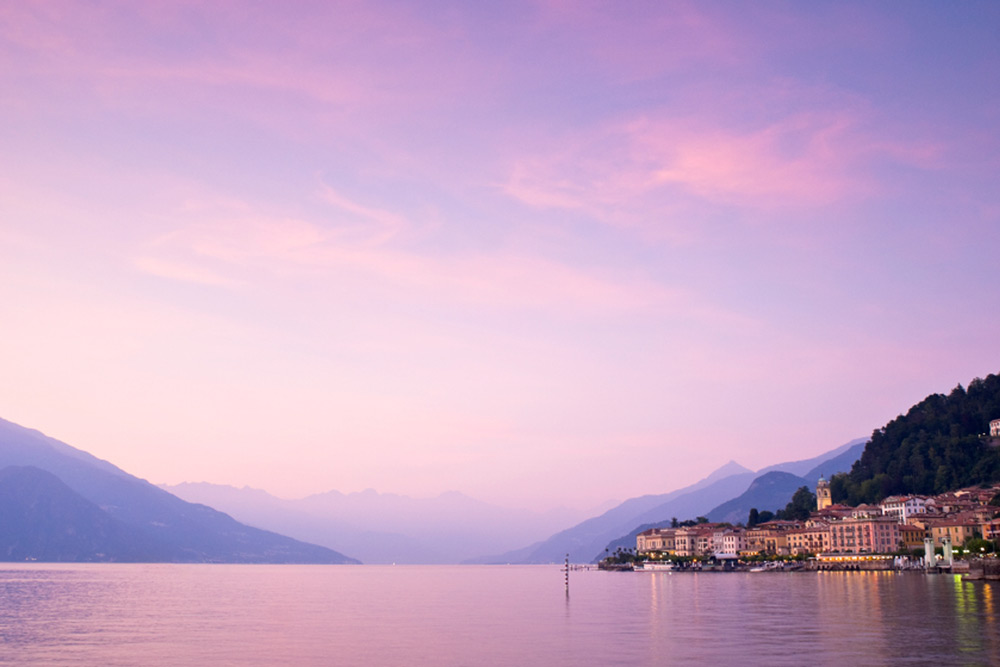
[625,472,1000,579]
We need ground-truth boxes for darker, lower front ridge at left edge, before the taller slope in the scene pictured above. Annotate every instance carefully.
[0,466,162,562]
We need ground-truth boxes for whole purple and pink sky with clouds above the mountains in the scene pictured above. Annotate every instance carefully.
[0,1,1000,507]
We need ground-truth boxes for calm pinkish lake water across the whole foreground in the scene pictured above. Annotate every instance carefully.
[0,564,1000,667]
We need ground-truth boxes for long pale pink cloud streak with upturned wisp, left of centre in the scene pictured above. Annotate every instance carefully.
[133,188,727,319]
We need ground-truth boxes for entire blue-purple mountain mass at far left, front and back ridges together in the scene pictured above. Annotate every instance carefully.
[0,419,355,563]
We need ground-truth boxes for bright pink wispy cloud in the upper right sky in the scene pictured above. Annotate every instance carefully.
[502,100,940,219]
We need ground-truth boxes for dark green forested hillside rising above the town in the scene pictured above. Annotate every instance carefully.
[830,375,1000,505]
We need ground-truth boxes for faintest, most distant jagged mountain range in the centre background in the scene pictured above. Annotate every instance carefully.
[162,482,581,564]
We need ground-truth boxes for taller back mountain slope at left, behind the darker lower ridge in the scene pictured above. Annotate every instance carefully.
[0,419,357,563]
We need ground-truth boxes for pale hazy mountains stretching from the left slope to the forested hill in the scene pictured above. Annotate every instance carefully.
[163,439,865,564]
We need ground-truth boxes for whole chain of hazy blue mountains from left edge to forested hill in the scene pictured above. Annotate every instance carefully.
[0,419,864,563]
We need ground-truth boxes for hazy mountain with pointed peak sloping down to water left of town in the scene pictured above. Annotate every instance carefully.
[477,461,753,563]
